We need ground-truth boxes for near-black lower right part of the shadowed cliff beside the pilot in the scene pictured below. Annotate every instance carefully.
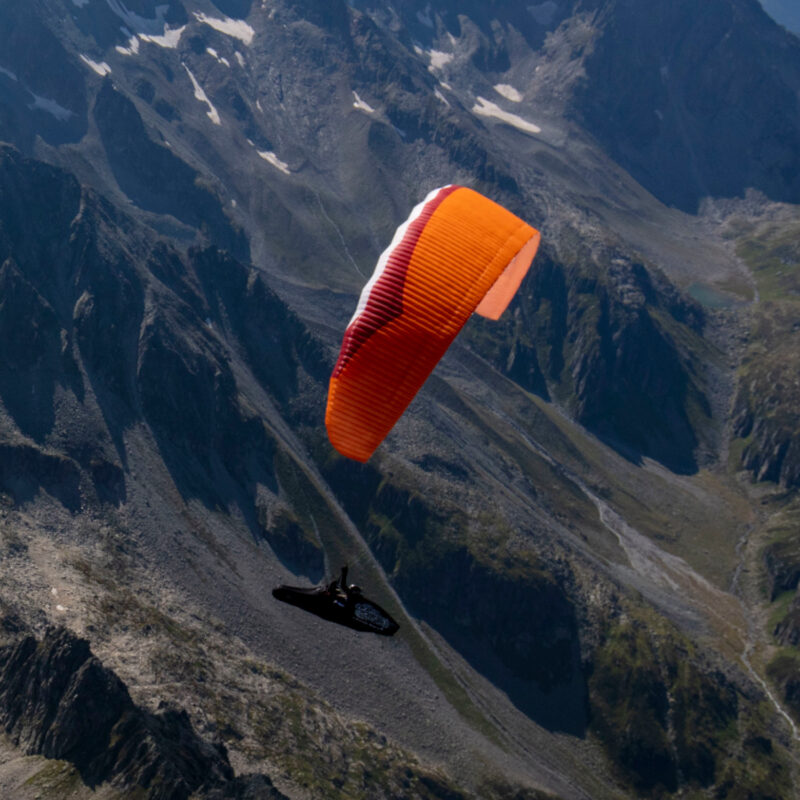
[396,541,587,735]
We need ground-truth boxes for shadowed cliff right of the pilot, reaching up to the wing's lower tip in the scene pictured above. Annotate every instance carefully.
[326,461,586,735]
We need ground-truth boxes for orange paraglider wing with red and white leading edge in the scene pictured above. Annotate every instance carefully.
[325,186,539,461]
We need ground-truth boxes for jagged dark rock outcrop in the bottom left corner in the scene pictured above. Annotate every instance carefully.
[0,628,283,800]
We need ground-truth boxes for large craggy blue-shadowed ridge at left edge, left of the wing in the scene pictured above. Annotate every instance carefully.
[0,148,330,528]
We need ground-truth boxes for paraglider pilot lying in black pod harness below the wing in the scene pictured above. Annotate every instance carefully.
[272,567,400,636]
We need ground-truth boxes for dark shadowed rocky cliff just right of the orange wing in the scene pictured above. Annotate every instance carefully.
[468,250,711,471]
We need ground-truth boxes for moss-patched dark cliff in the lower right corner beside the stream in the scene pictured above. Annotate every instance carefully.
[589,608,789,799]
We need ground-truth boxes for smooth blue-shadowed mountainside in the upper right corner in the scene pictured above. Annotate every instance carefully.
[571,0,800,211]
